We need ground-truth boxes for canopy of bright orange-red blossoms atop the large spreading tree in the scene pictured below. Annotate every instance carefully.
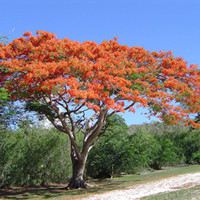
[0,31,199,129]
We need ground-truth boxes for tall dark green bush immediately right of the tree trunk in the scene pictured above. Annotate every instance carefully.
[86,115,128,178]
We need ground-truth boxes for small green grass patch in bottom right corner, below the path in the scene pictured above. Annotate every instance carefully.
[142,185,200,200]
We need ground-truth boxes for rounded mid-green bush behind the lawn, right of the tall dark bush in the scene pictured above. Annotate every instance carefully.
[119,128,179,173]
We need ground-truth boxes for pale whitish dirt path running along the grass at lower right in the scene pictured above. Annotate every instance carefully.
[85,173,200,200]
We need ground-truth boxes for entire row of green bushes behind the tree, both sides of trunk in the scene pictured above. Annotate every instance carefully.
[0,115,200,187]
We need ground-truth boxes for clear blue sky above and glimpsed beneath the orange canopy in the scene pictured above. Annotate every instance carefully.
[0,0,200,124]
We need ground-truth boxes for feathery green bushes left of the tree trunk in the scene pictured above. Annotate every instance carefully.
[0,126,71,187]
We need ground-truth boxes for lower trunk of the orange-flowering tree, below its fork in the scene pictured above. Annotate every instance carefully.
[67,146,87,189]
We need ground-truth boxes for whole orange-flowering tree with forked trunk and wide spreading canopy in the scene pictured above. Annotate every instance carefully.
[0,31,200,188]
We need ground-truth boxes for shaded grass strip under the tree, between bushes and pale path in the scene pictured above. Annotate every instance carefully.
[0,165,200,200]
